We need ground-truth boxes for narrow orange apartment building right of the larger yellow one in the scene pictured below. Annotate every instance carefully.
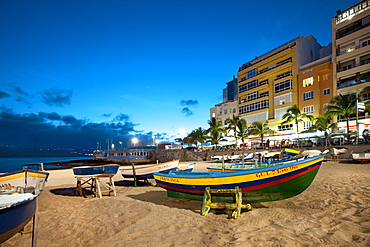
[298,44,334,129]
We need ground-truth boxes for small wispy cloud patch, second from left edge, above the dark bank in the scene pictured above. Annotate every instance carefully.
[41,88,73,107]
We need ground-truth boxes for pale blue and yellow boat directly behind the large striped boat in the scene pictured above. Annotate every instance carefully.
[207,157,304,172]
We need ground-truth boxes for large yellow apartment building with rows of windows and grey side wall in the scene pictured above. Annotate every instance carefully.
[238,36,321,134]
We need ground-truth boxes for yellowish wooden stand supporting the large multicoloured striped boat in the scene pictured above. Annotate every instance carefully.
[202,187,253,219]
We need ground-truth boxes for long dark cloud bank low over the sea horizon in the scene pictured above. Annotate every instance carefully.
[0,107,137,148]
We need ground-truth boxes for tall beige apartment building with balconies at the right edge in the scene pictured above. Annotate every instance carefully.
[332,0,370,131]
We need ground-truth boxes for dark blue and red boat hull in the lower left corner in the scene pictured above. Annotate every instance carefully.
[0,196,37,244]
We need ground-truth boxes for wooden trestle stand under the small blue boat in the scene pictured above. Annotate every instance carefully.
[76,174,117,198]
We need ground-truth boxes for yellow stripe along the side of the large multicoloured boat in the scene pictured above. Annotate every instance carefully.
[154,157,324,185]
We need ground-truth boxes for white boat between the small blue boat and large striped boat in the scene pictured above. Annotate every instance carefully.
[120,160,180,179]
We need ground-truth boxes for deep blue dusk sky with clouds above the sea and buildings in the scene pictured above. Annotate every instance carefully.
[0,0,356,148]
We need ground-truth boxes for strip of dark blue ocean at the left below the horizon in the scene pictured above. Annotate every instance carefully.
[0,156,92,173]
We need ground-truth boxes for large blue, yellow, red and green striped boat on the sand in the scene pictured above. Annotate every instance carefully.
[154,156,324,203]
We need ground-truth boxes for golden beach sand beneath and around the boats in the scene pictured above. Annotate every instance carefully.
[1,162,370,247]
